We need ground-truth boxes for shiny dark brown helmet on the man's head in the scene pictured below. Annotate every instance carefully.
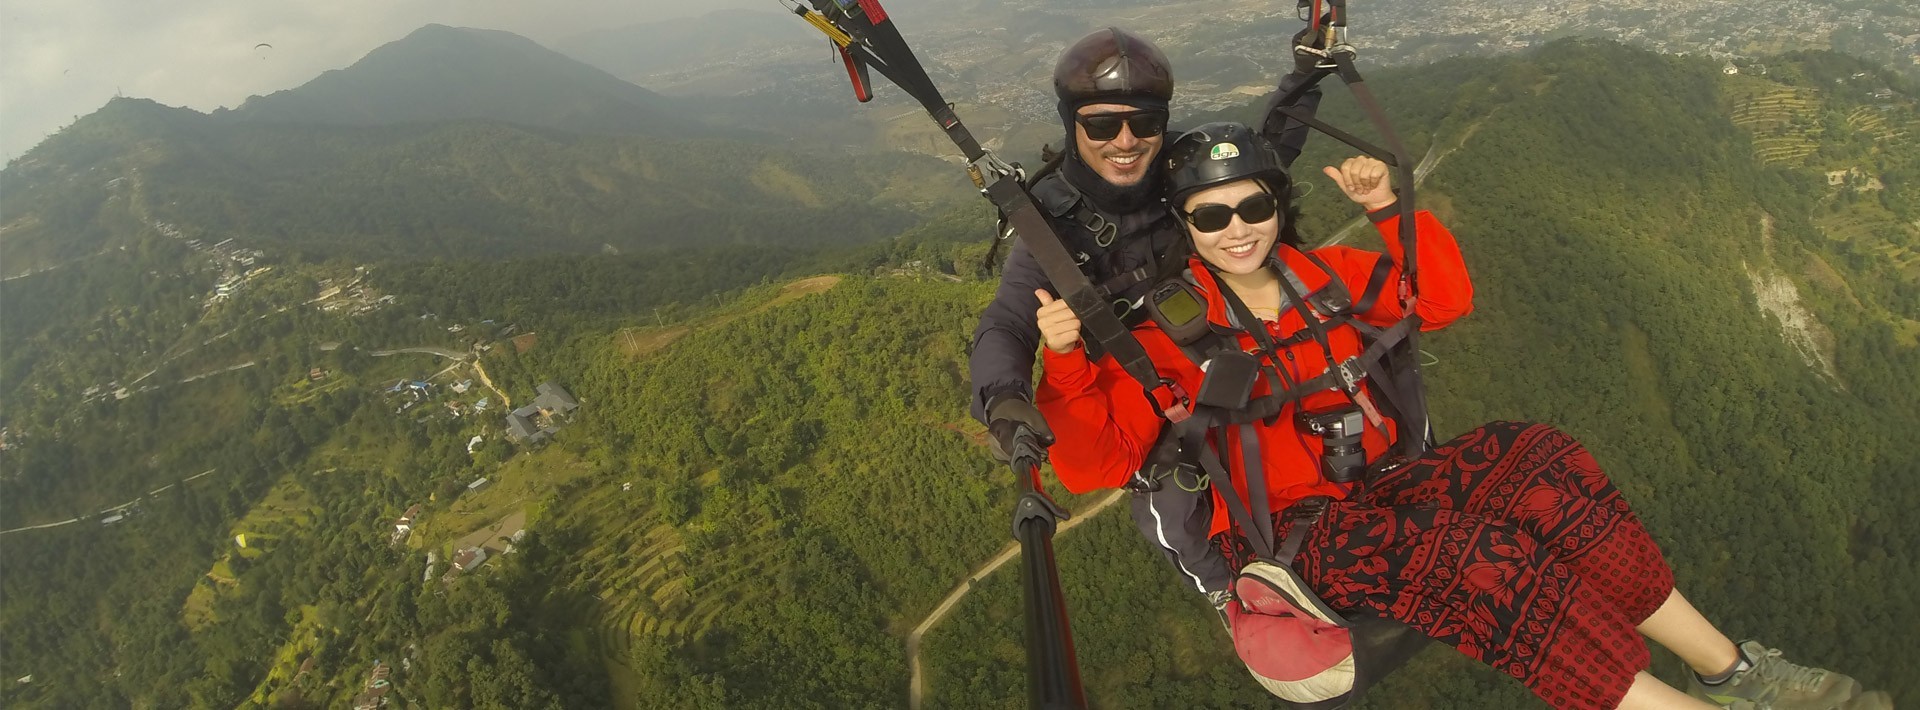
[1054,27,1173,113]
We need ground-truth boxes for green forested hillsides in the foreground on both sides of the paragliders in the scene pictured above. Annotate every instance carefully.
[0,42,1920,708]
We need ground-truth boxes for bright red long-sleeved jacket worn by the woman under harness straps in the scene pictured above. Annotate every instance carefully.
[1035,211,1473,533]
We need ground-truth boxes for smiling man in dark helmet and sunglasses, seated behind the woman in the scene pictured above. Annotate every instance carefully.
[968,27,1319,608]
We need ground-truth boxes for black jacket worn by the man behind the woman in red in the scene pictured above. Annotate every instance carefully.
[968,73,1321,422]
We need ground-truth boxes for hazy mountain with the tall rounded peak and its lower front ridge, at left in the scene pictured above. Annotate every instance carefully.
[0,25,966,276]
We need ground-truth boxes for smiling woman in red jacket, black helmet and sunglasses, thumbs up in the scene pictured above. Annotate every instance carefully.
[1035,123,1891,710]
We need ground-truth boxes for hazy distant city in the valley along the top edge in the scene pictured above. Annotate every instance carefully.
[622,0,1920,121]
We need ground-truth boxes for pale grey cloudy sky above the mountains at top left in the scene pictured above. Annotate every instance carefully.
[0,0,778,161]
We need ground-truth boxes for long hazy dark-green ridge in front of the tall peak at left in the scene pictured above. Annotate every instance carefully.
[0,100,966,274]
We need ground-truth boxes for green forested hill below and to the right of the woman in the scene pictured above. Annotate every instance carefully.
[929,42,1920,708]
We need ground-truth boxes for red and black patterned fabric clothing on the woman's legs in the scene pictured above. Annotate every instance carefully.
[1221,422,1672,710]
